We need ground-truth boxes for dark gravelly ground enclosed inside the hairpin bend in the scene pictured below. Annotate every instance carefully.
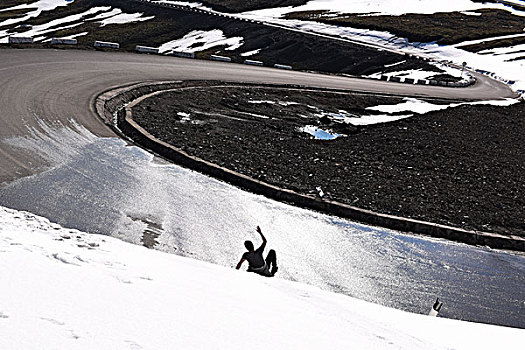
[134,83,525,236]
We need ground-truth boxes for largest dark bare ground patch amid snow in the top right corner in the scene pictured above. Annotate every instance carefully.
[287,9,525,45]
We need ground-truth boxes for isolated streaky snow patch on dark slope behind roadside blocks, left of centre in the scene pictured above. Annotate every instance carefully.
[159,29,244,53]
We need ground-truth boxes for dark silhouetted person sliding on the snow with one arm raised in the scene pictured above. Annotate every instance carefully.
[235,226,278,277]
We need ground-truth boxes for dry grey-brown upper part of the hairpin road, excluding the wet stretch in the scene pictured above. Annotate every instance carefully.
[0,50,513,184]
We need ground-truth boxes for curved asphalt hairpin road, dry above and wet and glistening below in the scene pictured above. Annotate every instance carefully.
[0,50,525,328]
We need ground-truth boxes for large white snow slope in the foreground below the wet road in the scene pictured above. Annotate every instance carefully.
[0,207,525,350]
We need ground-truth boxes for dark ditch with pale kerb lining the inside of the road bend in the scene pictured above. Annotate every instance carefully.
[95,82,525,251]
